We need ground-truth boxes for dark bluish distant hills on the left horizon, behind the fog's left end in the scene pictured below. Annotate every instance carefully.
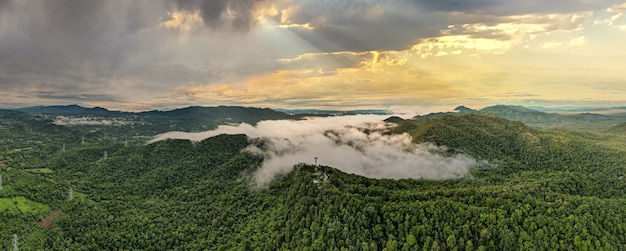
[12,105,301,136]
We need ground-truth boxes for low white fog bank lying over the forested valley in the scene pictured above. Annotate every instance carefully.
[152,115,478,186]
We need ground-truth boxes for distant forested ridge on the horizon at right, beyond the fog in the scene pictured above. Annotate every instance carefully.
[416,105,626,132]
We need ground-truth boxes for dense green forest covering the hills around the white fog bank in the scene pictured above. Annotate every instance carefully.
[0,106,626,250]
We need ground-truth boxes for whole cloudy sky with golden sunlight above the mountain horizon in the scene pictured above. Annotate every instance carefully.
[0,0,626,111]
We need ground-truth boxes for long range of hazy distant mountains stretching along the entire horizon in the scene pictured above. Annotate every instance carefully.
[8,105,626,134]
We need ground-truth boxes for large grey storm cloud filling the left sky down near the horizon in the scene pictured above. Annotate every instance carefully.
[0,0,288,109]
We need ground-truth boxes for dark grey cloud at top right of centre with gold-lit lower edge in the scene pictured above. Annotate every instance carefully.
[280,0,616,52]
